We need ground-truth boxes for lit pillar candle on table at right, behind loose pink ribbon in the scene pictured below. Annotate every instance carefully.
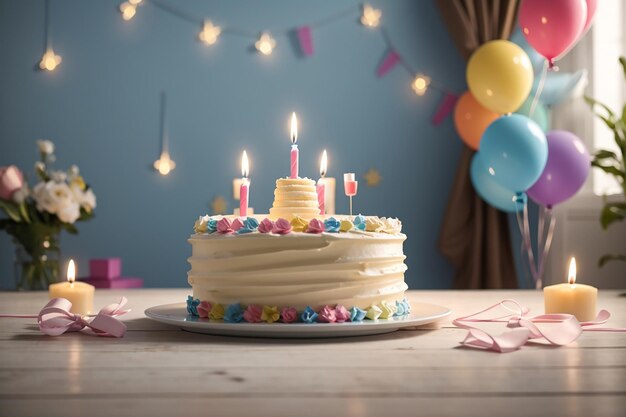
[543,258,598,322]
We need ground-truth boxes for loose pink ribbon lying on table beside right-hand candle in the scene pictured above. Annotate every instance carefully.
[452,300,626,353]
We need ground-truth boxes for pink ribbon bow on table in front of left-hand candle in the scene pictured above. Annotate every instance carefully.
[0,297,130,337]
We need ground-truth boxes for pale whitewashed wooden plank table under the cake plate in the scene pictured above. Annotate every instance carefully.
[0,289,626,417]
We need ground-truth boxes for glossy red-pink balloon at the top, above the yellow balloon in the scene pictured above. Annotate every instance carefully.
[519,0,587,66]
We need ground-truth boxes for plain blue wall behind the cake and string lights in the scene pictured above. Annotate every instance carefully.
[0,0,465,288]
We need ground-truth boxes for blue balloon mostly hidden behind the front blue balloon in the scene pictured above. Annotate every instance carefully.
[470,152,524,213]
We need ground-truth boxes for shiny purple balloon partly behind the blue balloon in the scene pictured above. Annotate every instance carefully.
[527,130,591,207]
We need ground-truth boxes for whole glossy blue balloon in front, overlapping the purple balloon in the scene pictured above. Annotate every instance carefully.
[479,114,548,192]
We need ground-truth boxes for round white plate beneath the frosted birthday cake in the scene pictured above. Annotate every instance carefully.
[145,303,450,338]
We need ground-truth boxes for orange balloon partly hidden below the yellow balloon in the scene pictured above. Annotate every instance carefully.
[454,91,500,150]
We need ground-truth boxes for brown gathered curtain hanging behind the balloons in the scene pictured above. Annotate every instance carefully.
[437,0,518,289]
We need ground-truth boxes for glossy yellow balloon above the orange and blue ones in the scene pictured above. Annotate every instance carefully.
[467,40,533,113]
